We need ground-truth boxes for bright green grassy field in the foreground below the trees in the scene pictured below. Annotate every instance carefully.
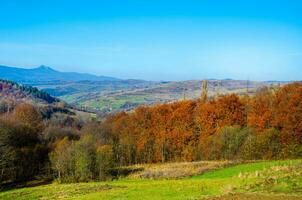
[0,160,302,200]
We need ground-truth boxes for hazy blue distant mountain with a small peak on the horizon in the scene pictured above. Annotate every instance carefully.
[0,65,119,85]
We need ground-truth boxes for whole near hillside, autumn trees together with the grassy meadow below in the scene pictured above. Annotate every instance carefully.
[0,82,302,200]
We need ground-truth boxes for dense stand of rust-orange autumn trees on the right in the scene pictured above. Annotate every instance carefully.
[104,83,302,165]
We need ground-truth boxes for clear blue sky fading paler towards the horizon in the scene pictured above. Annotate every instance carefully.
[0,0,302,80]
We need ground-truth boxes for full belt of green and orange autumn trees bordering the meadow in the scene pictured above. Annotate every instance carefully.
[0,82,302,183]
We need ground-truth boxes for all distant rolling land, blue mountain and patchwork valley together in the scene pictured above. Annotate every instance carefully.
[0,66,285,113]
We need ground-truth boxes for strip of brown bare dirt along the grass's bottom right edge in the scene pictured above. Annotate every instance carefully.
[205,194,302,200]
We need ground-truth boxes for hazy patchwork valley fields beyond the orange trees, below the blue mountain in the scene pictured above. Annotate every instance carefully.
[40,79,283,112]
